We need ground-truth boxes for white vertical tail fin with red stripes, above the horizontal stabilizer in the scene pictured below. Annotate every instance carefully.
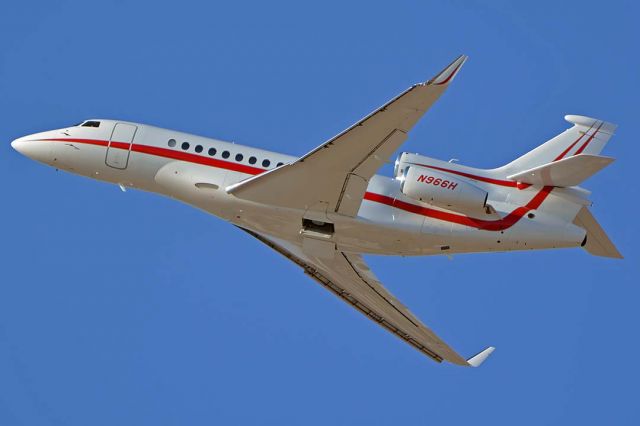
[503,115,617,175]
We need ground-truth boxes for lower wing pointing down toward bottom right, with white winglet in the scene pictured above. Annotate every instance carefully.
[240,228,494,367]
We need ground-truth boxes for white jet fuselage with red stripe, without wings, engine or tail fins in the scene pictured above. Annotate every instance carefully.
[12,120,588,255]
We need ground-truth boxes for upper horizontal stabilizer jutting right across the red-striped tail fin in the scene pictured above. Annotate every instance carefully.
[507,154,614,187]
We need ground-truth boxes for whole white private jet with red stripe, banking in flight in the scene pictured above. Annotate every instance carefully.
[11,55,622,367]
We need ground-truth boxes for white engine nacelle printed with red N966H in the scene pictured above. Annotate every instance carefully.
[400,166,489,213]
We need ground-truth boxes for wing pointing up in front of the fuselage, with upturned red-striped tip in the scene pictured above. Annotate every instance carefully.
[227,55,467,217]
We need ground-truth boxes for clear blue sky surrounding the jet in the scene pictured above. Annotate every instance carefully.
[0,0,640,425]
